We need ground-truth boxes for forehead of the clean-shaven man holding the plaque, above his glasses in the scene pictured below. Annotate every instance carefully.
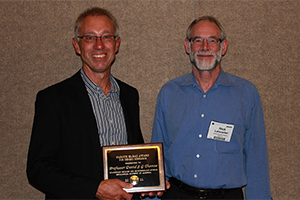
[79,15,116,34]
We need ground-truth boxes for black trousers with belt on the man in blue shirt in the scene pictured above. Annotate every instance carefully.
[161,178,244,200]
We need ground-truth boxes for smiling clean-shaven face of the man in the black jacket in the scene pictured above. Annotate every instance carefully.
[73,15,120,75]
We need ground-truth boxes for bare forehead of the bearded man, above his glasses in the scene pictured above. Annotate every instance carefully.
[191,21,221,38]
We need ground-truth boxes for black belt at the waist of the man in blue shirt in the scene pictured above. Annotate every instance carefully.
[169,177,241,199]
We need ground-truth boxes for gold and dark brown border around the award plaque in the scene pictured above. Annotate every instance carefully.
[102,142,166,193]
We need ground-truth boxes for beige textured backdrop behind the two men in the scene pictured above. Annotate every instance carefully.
[0,0,300,200]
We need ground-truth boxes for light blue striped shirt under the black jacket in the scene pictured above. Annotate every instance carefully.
[81,68,127,146]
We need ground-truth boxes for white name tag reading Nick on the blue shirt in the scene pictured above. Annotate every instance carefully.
[207,121,234,142]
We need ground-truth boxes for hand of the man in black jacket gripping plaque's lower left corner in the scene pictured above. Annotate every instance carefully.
[96,179,133,200]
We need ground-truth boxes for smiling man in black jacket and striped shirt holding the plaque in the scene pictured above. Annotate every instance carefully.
[27,8,144,199]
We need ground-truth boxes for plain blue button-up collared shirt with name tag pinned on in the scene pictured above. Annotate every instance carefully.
[152,70,271,199]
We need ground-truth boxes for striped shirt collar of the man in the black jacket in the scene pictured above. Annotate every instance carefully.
[80,68,120,93]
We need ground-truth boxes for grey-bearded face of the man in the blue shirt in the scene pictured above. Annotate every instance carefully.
[185,21,227,71]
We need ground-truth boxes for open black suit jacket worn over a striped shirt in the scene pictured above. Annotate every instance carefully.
[27,71,144,199]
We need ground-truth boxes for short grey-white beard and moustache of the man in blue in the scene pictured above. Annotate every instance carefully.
[189,44,223,71]
